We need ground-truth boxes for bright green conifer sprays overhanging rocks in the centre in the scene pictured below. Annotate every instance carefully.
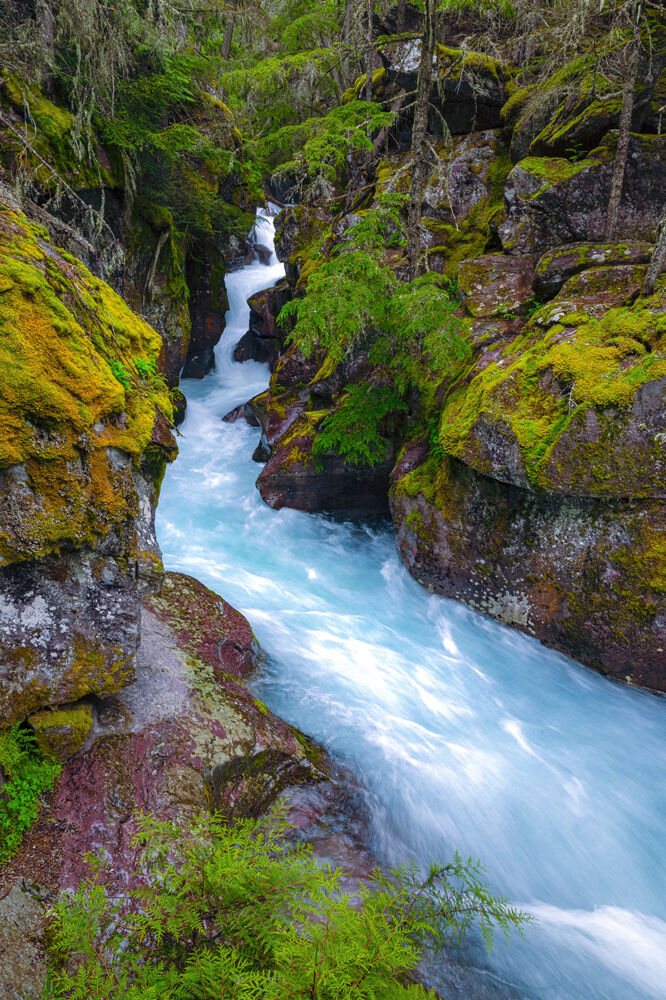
[279,200,471,466]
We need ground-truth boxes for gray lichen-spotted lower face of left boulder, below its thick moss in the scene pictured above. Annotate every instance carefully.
[0,460,161,728]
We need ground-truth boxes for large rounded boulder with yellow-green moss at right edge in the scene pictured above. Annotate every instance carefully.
[439,268,666,499]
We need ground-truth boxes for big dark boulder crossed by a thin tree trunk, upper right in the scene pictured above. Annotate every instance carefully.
[499,133,666,256]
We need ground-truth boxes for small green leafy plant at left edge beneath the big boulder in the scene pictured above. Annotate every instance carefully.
[0,724,61,864]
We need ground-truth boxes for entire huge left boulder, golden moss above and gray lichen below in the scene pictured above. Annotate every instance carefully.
[0,201,176,725]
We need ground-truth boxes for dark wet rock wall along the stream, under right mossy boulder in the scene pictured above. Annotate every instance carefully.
[391,459,666,691]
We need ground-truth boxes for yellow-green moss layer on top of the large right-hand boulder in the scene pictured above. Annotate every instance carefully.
[439,292,666,488]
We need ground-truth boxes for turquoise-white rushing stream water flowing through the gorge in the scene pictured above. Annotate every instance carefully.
[158,211,666,1000]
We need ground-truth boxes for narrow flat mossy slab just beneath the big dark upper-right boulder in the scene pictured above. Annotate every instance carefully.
[533,240,652,299]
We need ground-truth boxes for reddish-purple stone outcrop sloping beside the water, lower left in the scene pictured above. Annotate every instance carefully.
[0,573,332,1000]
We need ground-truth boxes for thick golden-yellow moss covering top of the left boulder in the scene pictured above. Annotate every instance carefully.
[0,210,172,565]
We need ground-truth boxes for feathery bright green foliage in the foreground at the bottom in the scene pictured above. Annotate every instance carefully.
[43,810,527,1000]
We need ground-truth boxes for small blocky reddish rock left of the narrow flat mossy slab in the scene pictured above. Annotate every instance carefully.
[458,254,534,317]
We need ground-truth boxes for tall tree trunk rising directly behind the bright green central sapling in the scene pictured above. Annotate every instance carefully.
[407,0,436,279]
